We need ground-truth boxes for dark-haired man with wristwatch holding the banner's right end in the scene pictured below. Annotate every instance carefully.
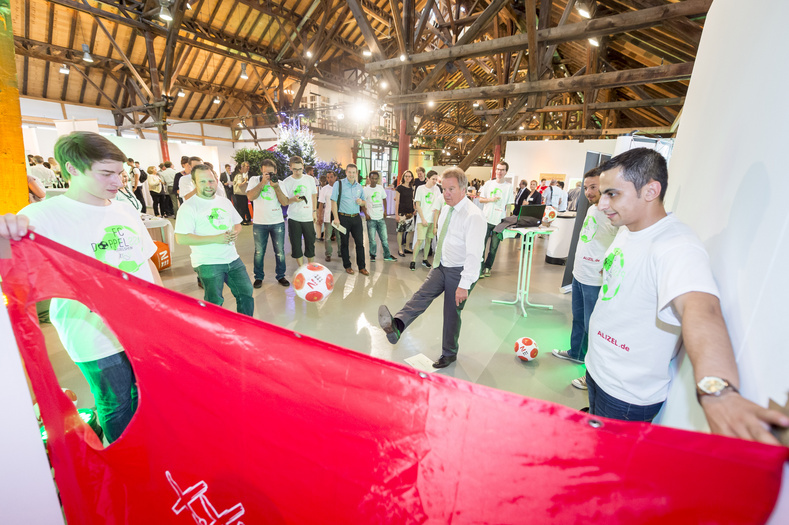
[586,148,787,444]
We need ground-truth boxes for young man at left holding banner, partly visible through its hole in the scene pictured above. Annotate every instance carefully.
[0,131,162,443]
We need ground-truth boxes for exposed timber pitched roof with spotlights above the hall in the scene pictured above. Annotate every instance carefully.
[12,0,712,165]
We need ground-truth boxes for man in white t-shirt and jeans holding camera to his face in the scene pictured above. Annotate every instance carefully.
[247,159,290,288]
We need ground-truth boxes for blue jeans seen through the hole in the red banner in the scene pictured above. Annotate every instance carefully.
[77,352,137,443]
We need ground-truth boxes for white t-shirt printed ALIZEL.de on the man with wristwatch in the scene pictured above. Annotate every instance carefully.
[586,215,719,406]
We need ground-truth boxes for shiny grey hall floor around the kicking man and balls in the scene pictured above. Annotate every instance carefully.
[42,219,587,414]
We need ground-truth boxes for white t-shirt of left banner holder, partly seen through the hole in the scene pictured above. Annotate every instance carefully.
[19,195,156,363]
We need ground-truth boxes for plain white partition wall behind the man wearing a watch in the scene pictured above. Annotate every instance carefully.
[662,0,789,525]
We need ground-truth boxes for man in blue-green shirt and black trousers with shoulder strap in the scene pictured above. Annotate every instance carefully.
[331,164,370,275]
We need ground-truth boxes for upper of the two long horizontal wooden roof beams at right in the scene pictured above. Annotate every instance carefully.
[366,0,712,72]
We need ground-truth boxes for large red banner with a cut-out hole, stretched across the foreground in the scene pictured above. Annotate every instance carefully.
[0,235,787,525]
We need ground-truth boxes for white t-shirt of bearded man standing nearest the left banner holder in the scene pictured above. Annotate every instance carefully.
[175,195,242,268]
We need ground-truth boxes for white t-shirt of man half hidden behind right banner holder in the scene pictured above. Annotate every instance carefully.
[573,204,619,286]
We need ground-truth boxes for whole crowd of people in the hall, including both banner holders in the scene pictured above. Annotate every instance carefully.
[0,132,789,443]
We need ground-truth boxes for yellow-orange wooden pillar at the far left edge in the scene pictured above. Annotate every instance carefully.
[0,0,30,214]
